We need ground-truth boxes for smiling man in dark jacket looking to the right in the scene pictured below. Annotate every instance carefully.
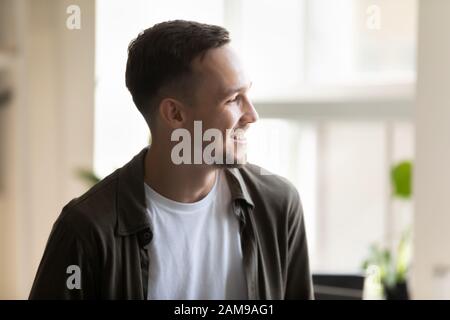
[30,20,312,299]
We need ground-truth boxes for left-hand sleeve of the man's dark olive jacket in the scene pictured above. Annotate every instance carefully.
[29,212,95,300]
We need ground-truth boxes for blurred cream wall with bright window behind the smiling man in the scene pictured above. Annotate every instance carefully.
[0,0,450,299]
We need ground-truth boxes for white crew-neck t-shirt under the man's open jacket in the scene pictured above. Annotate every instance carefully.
[145,170,247,300]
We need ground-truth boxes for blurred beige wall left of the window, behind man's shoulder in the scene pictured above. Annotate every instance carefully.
[0,0,95,298]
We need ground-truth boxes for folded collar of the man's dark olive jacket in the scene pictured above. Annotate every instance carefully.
[117,147,254,236]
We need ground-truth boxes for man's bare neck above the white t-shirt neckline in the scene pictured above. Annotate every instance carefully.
[144,145,219,203]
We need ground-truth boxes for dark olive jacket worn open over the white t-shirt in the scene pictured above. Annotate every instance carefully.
[30,148,313,299]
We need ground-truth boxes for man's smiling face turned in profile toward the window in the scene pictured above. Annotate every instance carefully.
[188,45,258,166]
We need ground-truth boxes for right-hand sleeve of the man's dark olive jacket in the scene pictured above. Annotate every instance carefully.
[285,189,314,299]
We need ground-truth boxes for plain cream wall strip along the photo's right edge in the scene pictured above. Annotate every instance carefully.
[412,0,450,299]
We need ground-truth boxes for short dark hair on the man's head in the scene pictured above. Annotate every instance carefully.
[125,20,230,125]
